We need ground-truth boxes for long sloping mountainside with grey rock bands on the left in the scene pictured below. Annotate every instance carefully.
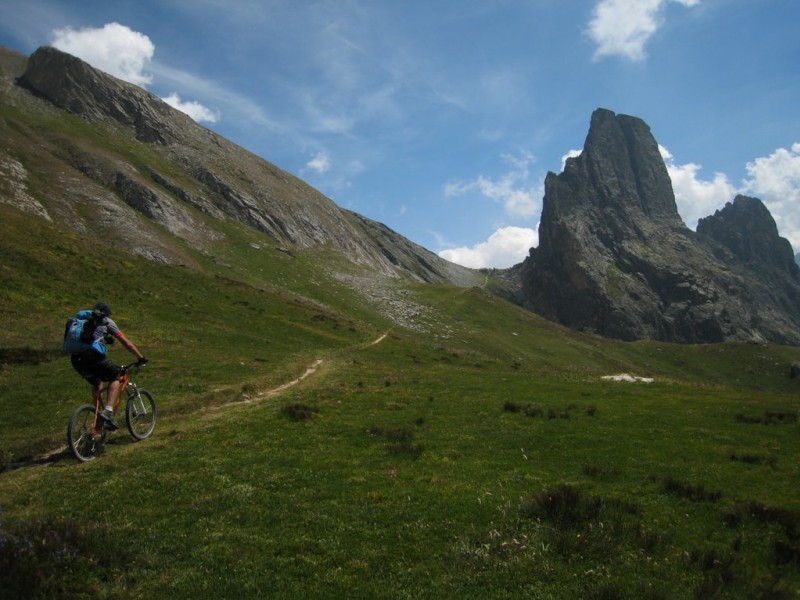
[0,47,478,285]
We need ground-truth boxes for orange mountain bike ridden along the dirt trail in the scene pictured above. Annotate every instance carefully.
[67,363,158,462]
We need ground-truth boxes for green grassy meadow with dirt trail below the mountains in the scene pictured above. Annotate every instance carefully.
[0,204,800,599]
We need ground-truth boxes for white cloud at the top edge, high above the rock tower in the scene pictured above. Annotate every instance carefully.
[587,0,700,61]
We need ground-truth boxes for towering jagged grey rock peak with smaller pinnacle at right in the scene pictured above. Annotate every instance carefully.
[513,109,800,344]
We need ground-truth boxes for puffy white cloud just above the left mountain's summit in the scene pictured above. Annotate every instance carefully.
[51,23,155,87]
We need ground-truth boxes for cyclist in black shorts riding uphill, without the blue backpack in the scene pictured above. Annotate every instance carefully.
[70,302,147,430]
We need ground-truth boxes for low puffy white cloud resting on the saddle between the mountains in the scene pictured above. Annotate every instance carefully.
[439,227,539,269]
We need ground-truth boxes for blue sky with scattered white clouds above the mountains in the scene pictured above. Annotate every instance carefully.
[0,0,800,267]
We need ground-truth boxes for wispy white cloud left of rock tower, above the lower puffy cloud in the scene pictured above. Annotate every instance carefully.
[444,152,544,219]
